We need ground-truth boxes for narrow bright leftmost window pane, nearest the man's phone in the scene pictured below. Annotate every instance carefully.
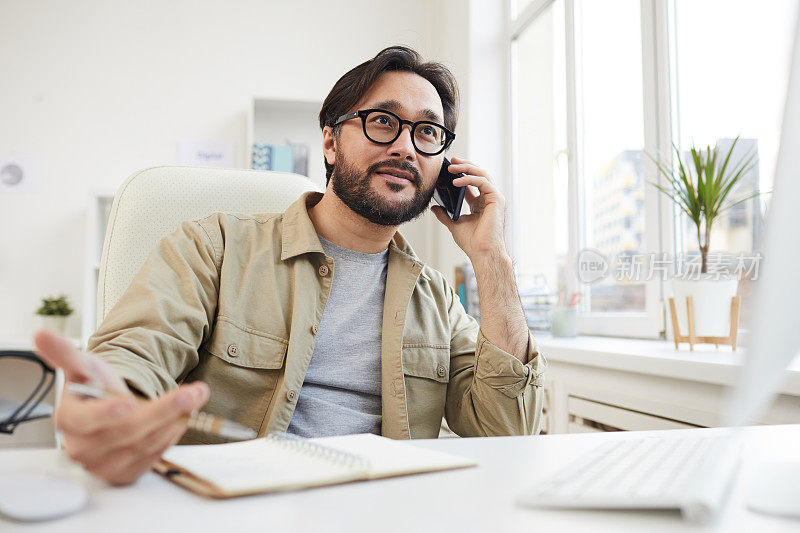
[514,0,568,328]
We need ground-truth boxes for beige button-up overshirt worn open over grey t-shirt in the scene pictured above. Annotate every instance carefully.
[88,192,546,443]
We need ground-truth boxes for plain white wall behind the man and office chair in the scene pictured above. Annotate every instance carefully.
[0,0,482,338]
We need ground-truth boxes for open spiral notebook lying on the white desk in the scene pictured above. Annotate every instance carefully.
[154,433,477,498]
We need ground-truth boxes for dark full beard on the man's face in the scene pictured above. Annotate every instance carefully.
[331,151,436,226]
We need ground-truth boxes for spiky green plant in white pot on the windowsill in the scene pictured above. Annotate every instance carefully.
[648,137,762,337]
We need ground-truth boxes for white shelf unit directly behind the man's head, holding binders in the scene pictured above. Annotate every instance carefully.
[244,97,325,187]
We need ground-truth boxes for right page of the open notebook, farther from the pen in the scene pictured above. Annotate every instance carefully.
[309,433,478,479]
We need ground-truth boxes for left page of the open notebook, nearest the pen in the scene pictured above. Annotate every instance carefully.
[162,438,365,494]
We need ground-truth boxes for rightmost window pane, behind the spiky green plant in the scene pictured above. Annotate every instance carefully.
[675,0,796,261]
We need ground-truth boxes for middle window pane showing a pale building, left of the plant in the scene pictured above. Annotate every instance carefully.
[576,0,646,312]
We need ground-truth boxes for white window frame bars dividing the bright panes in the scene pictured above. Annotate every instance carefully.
[506,0,676,338]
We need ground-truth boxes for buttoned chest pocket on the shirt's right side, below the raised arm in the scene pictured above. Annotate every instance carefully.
[402,344,450,439]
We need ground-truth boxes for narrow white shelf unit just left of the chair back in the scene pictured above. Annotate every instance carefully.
[81,189,115,347]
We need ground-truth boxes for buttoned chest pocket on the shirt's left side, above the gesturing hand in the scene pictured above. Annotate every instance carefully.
[181,316,288,443]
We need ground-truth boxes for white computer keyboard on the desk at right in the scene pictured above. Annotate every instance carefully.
[519,432,739,522]
